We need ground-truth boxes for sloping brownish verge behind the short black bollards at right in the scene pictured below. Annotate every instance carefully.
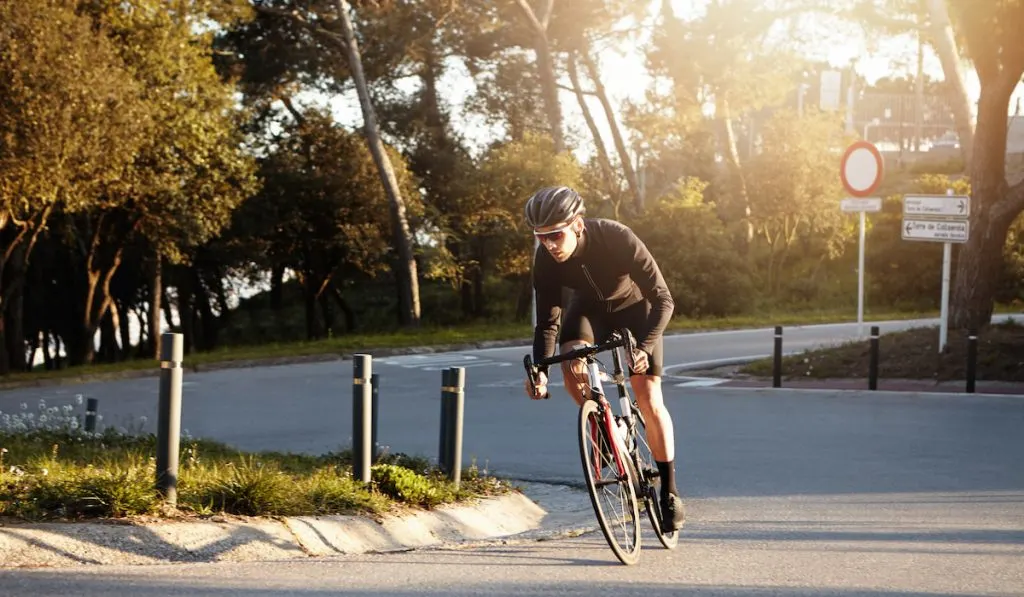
[738,321,1024,382]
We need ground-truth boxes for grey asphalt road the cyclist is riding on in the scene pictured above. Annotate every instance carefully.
[0,317,1024,597]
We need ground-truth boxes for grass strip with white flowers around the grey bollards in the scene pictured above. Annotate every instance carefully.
[0,402,512,520]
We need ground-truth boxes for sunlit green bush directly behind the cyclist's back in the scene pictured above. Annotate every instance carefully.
[631,178,754,317]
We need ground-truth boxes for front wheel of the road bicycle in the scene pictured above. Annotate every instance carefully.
[579,400,640,565]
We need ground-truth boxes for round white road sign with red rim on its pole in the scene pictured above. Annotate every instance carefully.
[840,141,885,336]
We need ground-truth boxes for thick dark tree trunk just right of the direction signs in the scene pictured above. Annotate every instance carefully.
[950,74,1024,328]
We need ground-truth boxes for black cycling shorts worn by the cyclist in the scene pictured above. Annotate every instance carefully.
[559,300,665,376]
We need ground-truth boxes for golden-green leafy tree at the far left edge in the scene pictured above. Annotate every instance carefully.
[0,0,155,372]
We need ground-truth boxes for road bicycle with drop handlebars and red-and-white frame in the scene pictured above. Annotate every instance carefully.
[523,329,679,565]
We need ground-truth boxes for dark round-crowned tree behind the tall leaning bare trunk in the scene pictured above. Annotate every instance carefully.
[231,110,422,339]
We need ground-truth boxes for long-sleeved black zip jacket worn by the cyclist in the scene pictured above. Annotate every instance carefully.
[534,218,675,359]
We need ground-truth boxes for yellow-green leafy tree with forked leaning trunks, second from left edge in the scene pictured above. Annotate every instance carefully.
[56,0,255,364]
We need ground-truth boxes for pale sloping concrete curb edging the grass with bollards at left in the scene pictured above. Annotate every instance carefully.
[0,483,594,568]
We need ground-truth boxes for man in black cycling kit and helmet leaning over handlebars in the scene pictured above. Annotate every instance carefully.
[525,186,684,530]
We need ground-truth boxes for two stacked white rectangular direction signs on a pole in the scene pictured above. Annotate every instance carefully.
[900,188,971,352]
